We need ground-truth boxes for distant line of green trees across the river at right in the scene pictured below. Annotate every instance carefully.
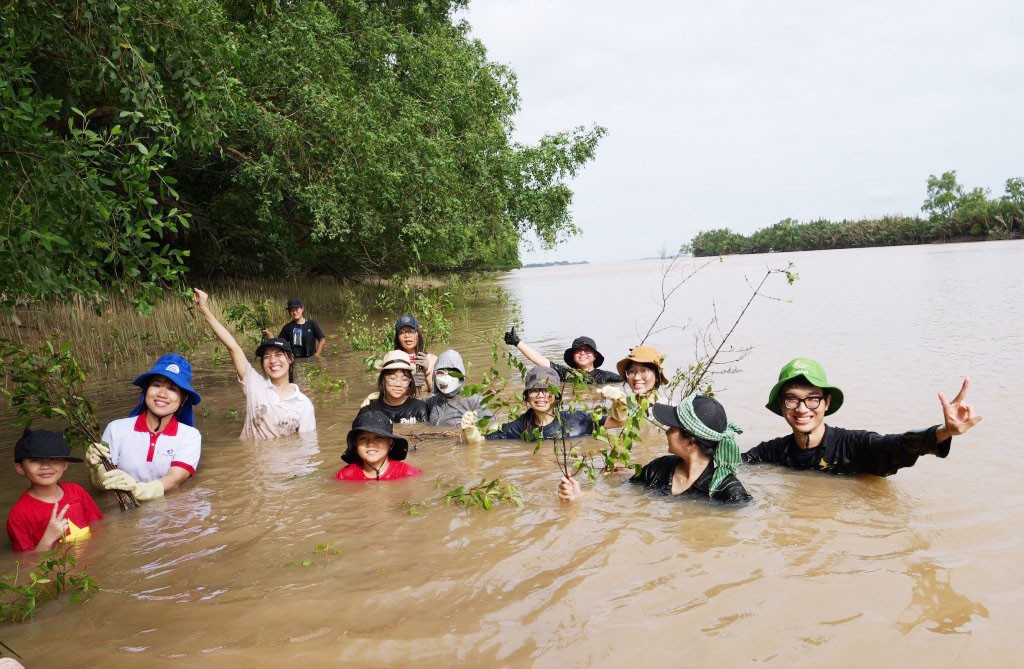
[690,171,1024,256]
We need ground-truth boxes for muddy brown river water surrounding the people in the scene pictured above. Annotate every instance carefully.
[0,241,1024,667]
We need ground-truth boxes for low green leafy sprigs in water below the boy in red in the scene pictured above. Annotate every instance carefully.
[0,543,99,622]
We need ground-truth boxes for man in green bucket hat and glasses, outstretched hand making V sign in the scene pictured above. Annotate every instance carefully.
[743,358,981,476]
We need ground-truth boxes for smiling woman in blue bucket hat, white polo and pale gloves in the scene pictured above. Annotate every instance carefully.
[85,353,202,501]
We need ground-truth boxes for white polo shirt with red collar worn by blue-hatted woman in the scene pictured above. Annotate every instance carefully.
[103,411,202,482]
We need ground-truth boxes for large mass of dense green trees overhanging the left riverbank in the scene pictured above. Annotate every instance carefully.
[0,0,604,312]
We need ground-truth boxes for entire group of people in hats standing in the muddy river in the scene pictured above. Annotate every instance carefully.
[7,289,981,550]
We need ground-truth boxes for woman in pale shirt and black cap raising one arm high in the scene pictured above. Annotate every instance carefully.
[193,288,316,440]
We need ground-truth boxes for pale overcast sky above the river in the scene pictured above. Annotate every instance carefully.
[465,0,1024,262]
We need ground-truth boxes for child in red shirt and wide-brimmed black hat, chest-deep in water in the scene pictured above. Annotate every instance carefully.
[334,410,420,480]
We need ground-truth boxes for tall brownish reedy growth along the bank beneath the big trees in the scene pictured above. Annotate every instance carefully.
[0,275,510,369]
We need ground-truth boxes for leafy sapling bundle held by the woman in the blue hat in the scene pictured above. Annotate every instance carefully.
[0,339,138,510]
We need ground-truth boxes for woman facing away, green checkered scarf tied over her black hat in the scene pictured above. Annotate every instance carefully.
[558,393,753,504]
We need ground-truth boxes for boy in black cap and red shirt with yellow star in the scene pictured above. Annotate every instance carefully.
[7,429,103,551]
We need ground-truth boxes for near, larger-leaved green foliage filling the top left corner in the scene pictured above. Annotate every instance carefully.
[0,0,231,311]
